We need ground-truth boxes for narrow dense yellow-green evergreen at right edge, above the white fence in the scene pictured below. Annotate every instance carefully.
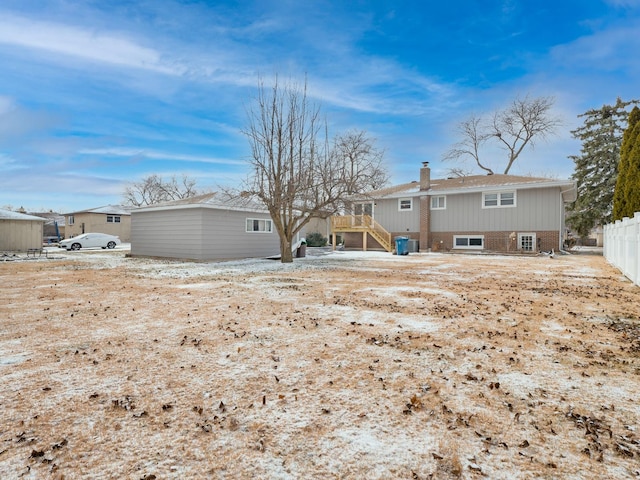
[612,107,640,221]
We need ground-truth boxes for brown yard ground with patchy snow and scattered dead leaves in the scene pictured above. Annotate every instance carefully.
[0,249,640,480]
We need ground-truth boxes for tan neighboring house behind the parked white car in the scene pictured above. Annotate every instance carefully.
[65,205,133,242]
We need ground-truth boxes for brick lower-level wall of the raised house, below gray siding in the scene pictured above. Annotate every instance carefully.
[430,231,560,252]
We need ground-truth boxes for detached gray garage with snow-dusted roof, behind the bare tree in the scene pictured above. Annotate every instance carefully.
[131,193,280,261]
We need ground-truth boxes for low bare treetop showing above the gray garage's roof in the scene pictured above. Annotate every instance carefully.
[123,174,198,207]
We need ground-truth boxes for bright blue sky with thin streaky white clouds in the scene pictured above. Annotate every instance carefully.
[0,0,640,212]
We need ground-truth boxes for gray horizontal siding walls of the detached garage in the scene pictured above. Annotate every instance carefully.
[131,208,280,261]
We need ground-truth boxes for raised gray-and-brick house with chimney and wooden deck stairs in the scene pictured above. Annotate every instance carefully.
[332,162,577,252]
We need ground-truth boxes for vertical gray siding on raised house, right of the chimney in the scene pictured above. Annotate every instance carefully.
[431,188,564,232]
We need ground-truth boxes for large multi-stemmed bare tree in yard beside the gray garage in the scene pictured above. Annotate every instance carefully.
[243,78,386,263]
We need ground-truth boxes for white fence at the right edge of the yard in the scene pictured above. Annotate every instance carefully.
[604,212,640,285]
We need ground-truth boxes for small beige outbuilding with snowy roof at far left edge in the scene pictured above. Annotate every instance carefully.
[0,210,44,252]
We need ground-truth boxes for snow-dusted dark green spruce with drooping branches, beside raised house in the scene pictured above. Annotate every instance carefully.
[567,98,639,236]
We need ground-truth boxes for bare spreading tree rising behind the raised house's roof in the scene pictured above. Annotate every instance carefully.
[443,97,561,175]
